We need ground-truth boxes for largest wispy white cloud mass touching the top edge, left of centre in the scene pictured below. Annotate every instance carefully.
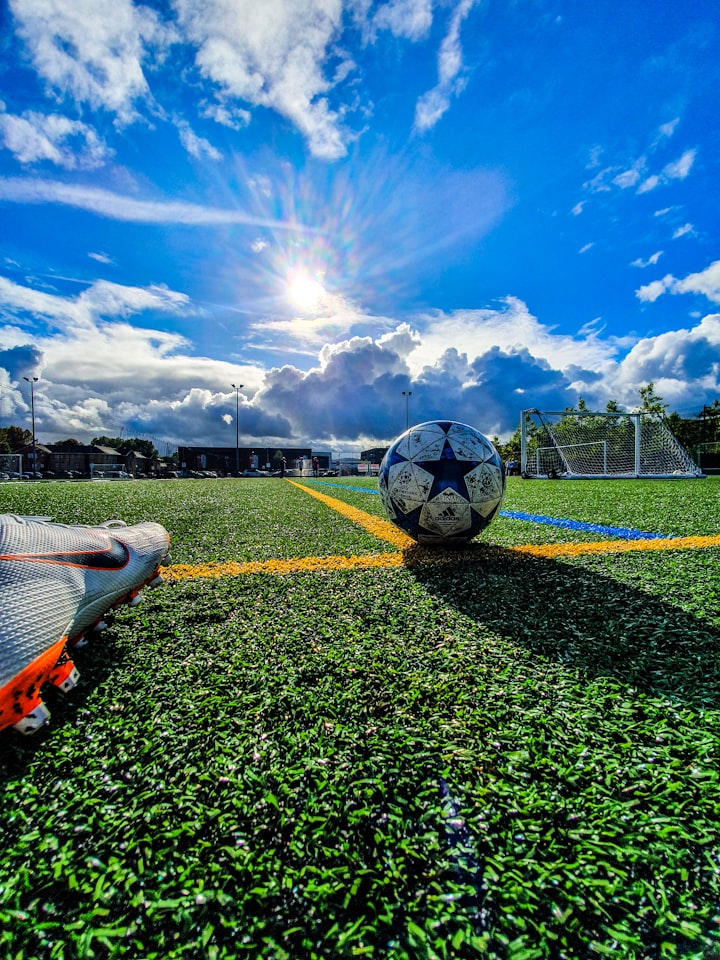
[11,0,360,160]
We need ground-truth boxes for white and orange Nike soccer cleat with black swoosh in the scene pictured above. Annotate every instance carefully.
[0,514,169,733]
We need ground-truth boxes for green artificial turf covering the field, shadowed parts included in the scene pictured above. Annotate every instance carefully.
[0,478,720,960]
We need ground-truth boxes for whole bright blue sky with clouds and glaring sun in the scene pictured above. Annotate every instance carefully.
[0,0,720,455]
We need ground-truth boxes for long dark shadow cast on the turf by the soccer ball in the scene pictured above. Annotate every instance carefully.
[405,544,720,708]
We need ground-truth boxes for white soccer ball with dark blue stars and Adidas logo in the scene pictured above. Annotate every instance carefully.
[378,420,505,546]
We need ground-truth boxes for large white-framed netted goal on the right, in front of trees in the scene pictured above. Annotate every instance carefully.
[520,409,703,479]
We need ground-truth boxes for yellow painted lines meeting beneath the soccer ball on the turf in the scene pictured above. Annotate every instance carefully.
[163,480,720,580]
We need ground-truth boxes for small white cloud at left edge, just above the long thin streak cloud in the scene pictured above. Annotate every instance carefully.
[0,110,112,170]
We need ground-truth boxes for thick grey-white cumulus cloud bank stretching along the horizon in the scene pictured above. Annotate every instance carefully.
[0,274,720,453]
